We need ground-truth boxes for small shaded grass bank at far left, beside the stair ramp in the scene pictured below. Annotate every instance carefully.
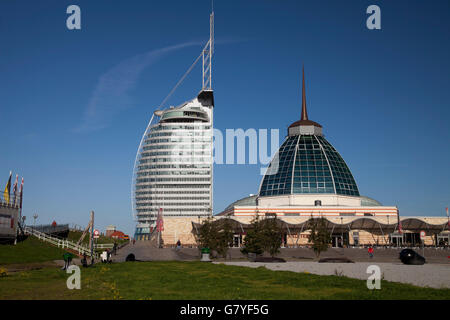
[0,237,65,265]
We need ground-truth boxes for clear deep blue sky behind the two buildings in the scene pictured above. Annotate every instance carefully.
[0,0,450,234]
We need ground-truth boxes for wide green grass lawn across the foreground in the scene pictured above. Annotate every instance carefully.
[0,262,450,300]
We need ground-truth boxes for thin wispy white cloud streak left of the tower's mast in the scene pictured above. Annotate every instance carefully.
[74,42,202,132]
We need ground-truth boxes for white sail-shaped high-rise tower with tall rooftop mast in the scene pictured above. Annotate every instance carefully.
[132,12,214,240]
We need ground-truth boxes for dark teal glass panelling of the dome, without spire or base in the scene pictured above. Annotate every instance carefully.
[259,135,359,196]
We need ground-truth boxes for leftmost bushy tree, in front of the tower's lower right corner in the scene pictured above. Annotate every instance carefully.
[196,217,234,257]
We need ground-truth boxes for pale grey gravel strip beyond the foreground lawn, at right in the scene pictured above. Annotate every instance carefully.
[218,261,450,288]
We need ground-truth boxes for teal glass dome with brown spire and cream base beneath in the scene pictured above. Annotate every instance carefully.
[221,72,397,216]
